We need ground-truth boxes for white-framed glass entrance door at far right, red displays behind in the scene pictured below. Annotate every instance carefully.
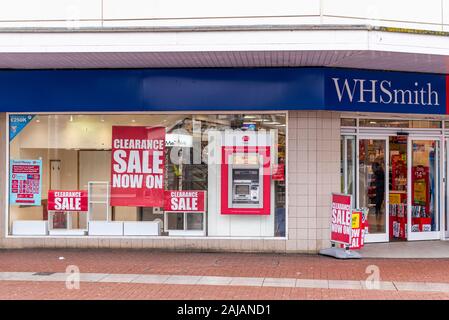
[407,137,441,240]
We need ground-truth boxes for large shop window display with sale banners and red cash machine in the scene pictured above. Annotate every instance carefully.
[9,113,286,237]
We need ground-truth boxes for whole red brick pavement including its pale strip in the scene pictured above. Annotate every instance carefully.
[0,249,449,299]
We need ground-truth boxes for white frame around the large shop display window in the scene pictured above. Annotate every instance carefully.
[4,110,289,241]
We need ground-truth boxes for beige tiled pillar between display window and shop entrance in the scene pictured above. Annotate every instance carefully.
[286,111,340,252]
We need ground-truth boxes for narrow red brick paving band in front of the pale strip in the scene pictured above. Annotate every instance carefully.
[0,281,449,300]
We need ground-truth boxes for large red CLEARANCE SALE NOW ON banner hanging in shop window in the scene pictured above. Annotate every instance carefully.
[111,126,165,207]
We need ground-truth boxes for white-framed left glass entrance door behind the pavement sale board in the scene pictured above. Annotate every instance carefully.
[357,137,389,242]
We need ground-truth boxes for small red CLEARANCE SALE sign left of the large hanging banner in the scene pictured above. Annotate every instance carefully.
[47,190,88,211]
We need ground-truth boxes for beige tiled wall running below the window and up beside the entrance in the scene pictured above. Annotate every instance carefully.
[0,111,340,253]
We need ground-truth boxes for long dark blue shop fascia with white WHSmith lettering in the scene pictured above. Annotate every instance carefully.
[0,68,449,114]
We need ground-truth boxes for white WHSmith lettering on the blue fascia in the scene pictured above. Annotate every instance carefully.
[332,78,440,106]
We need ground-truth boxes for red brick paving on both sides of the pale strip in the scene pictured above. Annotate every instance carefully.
[0,249,449,300]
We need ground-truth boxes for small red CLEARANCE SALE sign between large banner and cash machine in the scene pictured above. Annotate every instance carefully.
[164,190,205,212]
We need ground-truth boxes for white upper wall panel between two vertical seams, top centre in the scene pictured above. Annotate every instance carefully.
[103,0,320,19]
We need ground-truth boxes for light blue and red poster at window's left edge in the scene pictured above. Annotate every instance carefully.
[9,159,42,206]
